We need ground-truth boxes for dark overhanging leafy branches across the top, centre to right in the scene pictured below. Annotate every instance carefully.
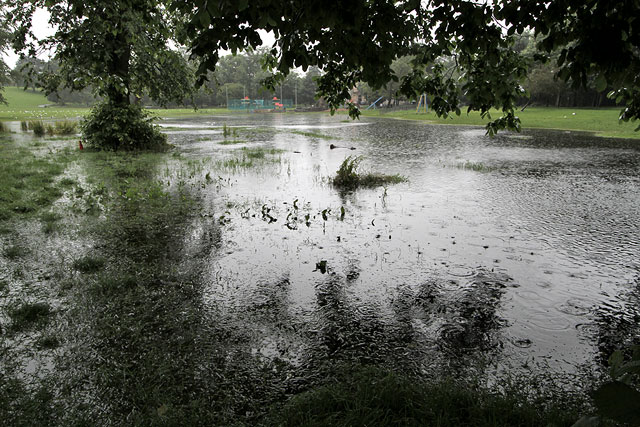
[173,0,640,134]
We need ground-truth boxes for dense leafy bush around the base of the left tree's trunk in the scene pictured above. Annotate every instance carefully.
[80,101,167,151]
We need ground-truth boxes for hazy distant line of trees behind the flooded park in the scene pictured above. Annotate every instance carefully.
[5,40,616,108]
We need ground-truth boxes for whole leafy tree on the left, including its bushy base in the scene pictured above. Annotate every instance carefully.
[1,0,193,149]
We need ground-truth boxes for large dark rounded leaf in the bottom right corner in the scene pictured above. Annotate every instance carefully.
[593,381,640,425]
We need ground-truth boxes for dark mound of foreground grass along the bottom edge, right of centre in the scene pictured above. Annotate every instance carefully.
[267,367,582,427]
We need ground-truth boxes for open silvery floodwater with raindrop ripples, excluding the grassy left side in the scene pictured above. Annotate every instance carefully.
[163,114,640,371]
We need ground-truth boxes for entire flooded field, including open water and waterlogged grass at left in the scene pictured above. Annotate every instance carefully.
[0,114,640,424]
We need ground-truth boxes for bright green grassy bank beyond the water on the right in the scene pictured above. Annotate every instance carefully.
[362,107,640,138]
